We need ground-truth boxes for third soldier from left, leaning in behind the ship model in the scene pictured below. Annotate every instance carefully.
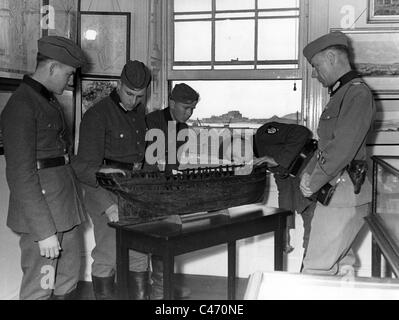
[146,83,199,300]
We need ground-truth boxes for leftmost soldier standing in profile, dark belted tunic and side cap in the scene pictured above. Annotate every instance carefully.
[1,36,86,299]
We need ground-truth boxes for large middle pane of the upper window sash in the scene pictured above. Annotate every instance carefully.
[216,20,255,61]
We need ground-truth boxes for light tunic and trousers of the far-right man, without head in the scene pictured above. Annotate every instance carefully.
[303,72,375,274]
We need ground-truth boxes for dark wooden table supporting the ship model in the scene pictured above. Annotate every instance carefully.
[109,205,292,300]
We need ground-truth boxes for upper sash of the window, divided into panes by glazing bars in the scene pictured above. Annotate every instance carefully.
[170,0,300,75]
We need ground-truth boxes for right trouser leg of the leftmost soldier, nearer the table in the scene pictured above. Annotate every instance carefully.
[54,227,82,299]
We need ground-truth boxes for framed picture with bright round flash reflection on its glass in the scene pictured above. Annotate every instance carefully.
[78,11,131,78]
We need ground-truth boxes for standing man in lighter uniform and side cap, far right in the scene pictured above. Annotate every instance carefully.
[300,32,375,276]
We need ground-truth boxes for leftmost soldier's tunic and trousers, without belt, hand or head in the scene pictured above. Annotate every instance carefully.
[1,76,85,299]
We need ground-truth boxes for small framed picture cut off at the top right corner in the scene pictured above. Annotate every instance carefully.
[367,0,399,23]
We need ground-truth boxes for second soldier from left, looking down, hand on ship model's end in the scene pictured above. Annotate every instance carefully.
[73,61,151,300]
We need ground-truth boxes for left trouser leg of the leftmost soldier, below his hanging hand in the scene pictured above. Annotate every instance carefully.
[19,234,58,300]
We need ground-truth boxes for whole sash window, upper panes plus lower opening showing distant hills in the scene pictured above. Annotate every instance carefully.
[167,0,305,129]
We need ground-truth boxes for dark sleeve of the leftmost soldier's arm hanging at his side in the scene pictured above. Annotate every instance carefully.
[2,101,57,241]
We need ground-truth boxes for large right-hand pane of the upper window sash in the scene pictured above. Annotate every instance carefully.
[258,19,298,60]
